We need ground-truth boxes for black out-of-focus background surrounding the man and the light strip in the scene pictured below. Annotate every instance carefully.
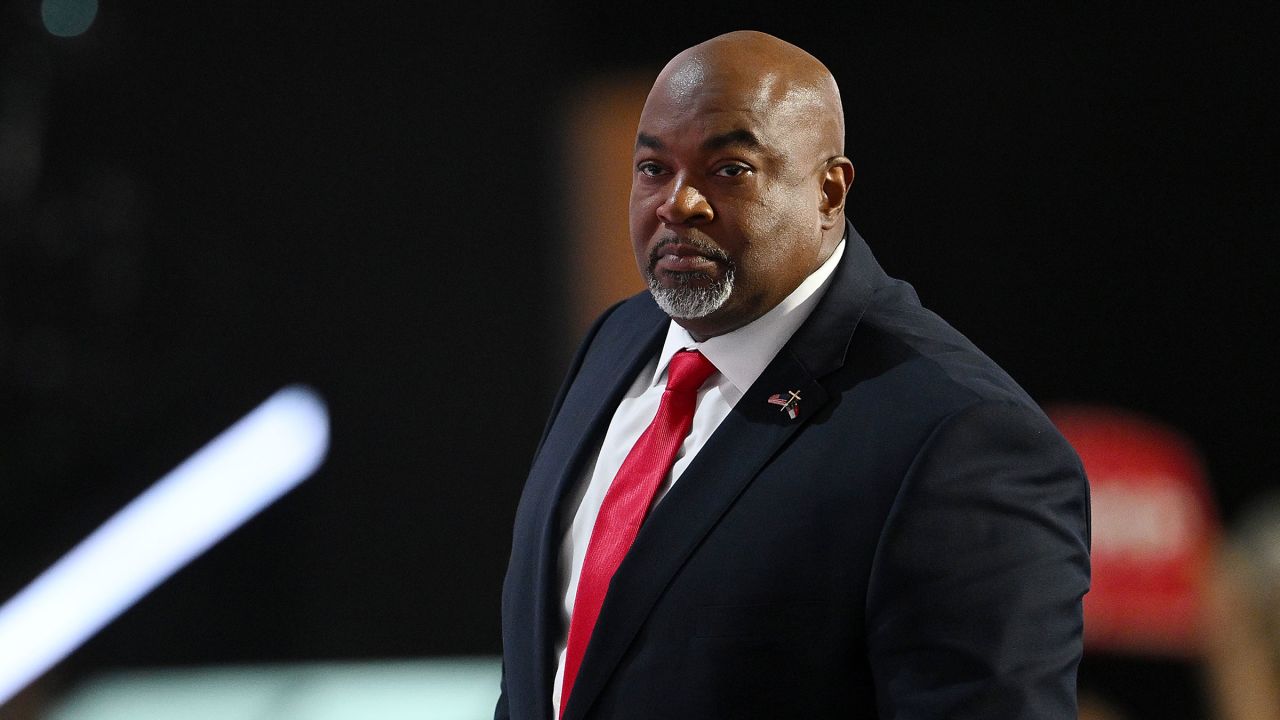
[0,0,1280,696]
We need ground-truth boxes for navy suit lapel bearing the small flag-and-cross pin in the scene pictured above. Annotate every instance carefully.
[564,227,879,720]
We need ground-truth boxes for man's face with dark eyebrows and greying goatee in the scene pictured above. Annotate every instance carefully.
[631,63,826,340]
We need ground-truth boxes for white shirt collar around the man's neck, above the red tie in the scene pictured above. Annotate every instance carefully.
[650,241,845,402]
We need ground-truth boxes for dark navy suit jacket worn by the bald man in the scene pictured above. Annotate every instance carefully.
[497,221,1089,720]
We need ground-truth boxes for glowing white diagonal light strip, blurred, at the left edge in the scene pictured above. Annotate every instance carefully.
[0,386,329,705]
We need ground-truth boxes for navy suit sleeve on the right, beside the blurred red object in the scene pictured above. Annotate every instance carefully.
[867,402,1089,720]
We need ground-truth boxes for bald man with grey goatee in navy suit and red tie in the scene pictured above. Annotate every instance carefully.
[497,32,1088,720]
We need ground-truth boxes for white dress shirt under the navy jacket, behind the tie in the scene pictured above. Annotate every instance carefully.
[552,241,845,717]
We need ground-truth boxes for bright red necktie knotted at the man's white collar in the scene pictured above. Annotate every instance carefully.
[559,350,716,716]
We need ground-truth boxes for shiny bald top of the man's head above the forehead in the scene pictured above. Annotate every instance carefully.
[650,29,845,156]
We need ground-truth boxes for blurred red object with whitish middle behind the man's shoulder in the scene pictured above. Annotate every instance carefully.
[1048,406,1221,656]
